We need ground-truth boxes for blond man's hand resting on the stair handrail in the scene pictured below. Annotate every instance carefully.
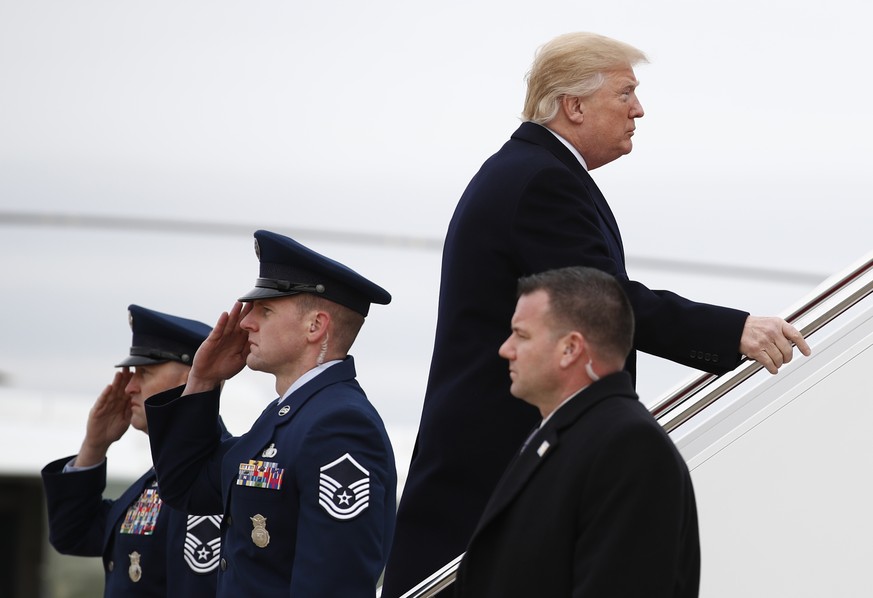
[740,316,812,374]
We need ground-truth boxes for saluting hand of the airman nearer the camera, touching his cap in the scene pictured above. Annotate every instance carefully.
[182,301,252,396]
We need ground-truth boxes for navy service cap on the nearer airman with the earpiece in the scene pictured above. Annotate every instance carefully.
[239,230,391,317]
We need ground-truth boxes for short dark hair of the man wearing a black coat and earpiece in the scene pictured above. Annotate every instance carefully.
[518,266,634,364]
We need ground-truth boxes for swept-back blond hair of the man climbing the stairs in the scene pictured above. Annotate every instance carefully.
[522,32,648,125]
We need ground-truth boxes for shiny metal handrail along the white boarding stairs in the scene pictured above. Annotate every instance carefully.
[390,257,873,598]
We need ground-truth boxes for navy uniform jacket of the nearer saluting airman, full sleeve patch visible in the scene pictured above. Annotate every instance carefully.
[146,357,397,598]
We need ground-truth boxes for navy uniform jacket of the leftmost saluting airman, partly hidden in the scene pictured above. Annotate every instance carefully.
[42,457,220,598]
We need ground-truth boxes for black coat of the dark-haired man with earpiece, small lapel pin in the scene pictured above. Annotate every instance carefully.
[455,372,700,598]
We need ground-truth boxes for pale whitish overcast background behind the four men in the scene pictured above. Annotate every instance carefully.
[0,0,873,480]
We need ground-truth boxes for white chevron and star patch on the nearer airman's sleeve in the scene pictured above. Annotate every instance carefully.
[318,453,370,519]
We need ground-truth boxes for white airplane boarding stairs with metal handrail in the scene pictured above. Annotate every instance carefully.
[392,254,873,598]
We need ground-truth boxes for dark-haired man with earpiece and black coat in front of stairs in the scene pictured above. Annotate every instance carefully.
[455,267,700,598]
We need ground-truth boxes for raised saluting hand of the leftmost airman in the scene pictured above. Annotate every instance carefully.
[75,368,133,467]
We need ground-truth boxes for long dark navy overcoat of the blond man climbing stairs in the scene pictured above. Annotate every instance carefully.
[383,123,748,598]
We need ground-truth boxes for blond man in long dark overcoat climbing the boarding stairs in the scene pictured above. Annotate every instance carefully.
[383,33,809,598]
